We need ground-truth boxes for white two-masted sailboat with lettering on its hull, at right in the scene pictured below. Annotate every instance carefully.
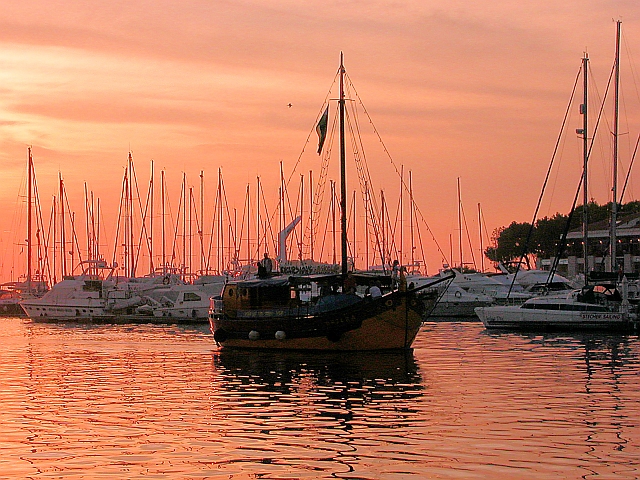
[475,22,638,332]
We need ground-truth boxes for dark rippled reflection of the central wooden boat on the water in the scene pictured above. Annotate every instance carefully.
[213,350,423,475]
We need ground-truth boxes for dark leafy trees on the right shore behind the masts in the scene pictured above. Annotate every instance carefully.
[484,201,640,268]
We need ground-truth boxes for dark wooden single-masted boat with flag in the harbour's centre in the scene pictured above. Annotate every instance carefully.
[209,54,452,351]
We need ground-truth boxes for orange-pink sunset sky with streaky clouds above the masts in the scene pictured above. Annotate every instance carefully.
[0,0,640,281]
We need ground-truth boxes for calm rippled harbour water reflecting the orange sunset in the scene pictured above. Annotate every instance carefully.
[0,319,640,479]
